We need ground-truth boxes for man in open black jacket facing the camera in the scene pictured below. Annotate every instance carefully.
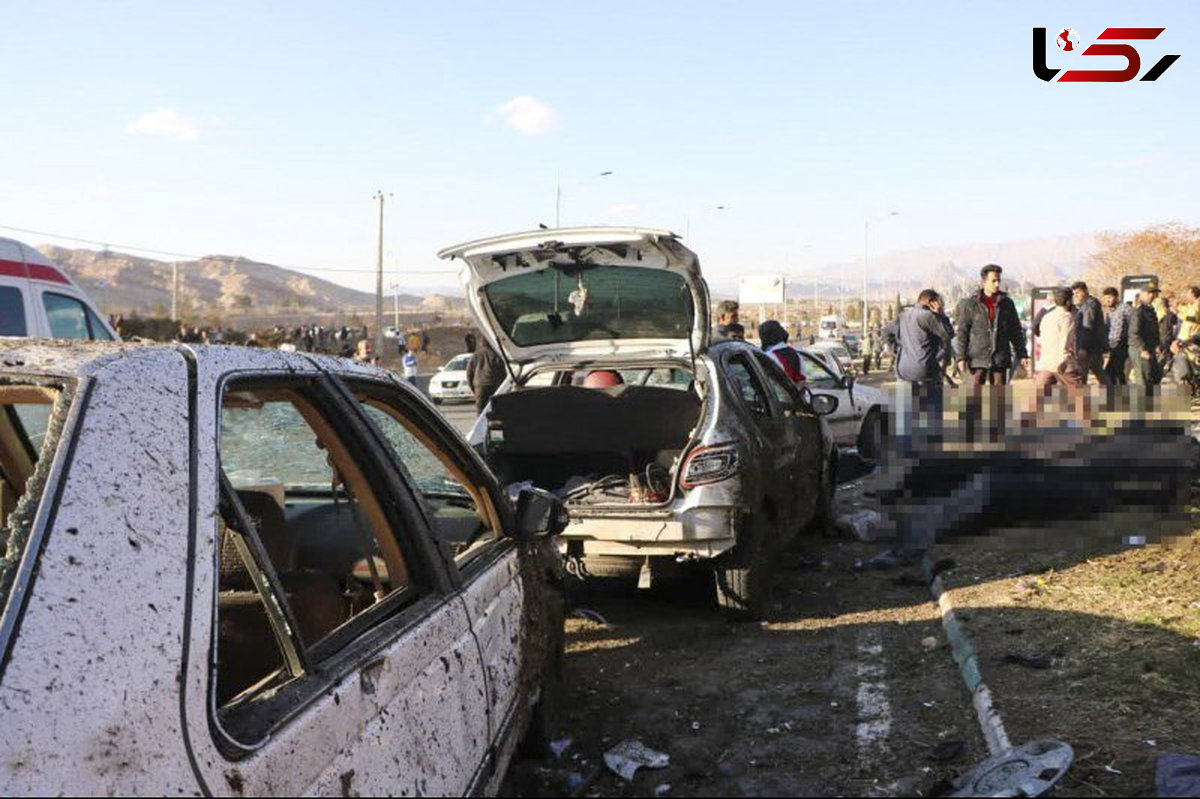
[954,264,1030,386]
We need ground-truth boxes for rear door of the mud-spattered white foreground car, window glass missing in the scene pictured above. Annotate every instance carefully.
[184,364,488,795]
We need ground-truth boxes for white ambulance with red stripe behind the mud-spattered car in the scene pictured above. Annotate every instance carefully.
[0,239,118,341]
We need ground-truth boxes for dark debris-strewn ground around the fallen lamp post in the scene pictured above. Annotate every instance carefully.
[510,429,1200,797]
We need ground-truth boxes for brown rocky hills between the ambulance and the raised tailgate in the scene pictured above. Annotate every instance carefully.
[40,245,463,316]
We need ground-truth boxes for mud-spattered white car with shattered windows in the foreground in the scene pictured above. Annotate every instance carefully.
[0,342,565,795]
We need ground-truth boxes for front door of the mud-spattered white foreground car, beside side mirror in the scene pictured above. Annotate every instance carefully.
[338,379,544,782]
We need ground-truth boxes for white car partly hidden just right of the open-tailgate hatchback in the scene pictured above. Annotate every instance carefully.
[799,347,888,461]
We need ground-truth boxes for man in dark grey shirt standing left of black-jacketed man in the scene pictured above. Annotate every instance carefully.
[882,289,950,429]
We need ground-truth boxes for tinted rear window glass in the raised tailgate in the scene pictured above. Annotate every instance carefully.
[484,266,695,347]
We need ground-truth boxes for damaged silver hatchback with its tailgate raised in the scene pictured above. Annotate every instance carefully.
[439,228,838,615]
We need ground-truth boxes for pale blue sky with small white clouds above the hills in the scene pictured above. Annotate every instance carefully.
[0,0,1200,290]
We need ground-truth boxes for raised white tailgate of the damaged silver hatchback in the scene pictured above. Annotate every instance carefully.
[438,227,709,364]
